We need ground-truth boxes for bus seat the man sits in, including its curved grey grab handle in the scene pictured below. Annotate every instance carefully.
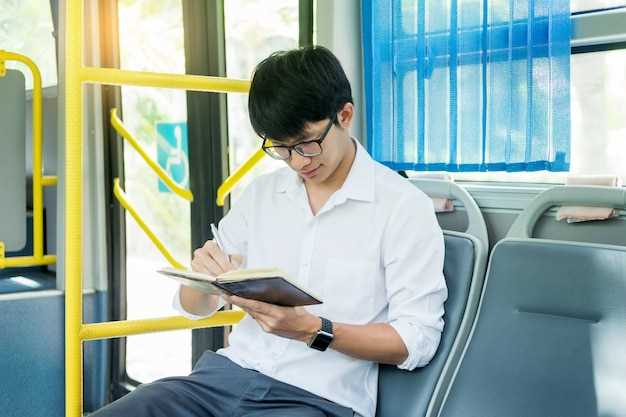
[376,179,488,417]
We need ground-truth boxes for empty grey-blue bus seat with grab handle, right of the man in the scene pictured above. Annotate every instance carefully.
[439,187,626,417]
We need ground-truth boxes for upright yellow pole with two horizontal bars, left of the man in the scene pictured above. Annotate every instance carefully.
[64,4,250,417]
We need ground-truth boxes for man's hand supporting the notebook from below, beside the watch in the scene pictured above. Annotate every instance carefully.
[224,295,322,343]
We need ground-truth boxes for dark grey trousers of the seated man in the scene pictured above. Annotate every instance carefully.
[91,351,354,417]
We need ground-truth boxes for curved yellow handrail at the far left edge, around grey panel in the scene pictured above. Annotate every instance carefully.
[0,50,57,269]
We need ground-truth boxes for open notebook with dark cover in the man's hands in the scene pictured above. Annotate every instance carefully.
[157,268,322,307]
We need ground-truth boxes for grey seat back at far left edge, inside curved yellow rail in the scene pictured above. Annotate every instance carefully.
[0,70,26,251]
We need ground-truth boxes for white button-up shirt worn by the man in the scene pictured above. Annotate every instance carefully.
[174,141,447,417]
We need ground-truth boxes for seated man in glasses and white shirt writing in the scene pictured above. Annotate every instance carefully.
[91,47,447,417]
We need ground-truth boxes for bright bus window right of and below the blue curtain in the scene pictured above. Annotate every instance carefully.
[394,5,626,183]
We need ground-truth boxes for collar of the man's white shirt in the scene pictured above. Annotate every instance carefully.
[275,138,375,202]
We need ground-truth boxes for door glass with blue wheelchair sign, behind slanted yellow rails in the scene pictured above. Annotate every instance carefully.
[118,0,191,382]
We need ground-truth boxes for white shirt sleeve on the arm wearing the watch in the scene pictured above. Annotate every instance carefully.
[382,189,448,370]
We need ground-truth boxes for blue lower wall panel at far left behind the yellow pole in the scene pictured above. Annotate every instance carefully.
[0,290,102,417]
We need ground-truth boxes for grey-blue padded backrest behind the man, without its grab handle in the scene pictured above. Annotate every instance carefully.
[376,234,474,417]
